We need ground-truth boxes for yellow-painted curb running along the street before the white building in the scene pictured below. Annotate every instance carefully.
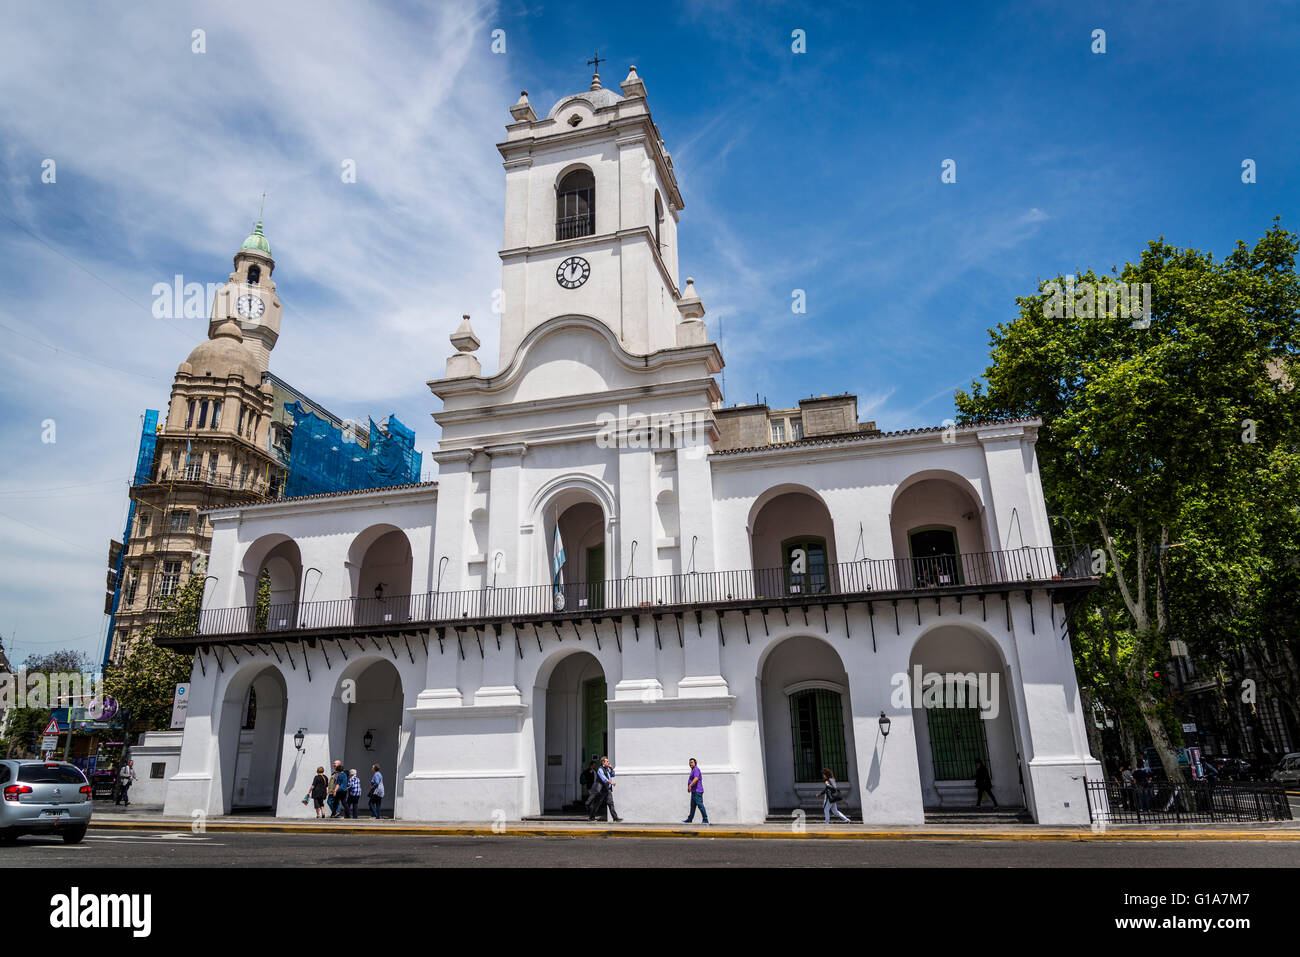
[90,820,1300,843]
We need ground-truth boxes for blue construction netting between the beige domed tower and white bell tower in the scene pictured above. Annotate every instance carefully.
[283,402,424,498]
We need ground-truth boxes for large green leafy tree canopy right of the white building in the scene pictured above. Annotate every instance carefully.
[956,222,1300,767]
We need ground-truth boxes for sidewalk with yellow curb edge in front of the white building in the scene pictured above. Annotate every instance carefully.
[90,802,1300,843]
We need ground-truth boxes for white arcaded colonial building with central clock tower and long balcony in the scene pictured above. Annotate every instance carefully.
[164,68,1100,823]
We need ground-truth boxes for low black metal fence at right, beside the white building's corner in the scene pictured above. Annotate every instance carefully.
[1087,780,1291,824]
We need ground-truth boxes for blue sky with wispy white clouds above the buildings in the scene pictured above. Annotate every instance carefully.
[0,1,1300,659]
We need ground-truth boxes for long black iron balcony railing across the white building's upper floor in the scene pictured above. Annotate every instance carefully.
[163,547,1091,637]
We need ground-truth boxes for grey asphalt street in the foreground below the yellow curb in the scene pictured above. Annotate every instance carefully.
[0,830,1300,869]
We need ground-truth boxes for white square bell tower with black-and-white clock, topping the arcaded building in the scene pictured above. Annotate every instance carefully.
[497,66,703,368]
